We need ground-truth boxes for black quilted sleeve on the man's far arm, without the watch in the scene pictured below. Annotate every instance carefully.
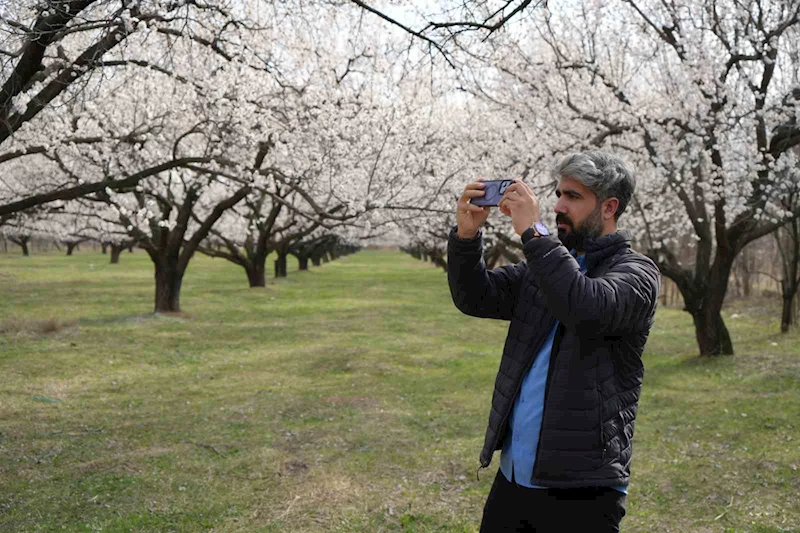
[447,228,525,320]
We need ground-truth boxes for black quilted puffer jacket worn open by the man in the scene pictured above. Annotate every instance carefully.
[447,228,660,488]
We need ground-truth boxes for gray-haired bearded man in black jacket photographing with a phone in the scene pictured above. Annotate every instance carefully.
[447,152,660,533]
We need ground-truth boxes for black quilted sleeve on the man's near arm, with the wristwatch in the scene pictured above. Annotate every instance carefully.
[524,237,660,334]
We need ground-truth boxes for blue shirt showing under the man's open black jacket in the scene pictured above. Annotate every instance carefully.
[500,251,628,494]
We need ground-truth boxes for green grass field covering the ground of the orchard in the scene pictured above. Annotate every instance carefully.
[0,251,800,533]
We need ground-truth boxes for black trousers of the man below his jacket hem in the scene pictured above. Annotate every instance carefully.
[481,470,625,533]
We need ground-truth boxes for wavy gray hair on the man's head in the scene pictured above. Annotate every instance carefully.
[552,152,636,220]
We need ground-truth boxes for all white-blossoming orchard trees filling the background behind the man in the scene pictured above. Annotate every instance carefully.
[0,0,800,355]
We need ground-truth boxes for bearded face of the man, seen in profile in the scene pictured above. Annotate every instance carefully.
[555,178,603,251]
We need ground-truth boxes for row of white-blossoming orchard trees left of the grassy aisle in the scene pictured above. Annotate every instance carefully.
[0,0,524,311]
